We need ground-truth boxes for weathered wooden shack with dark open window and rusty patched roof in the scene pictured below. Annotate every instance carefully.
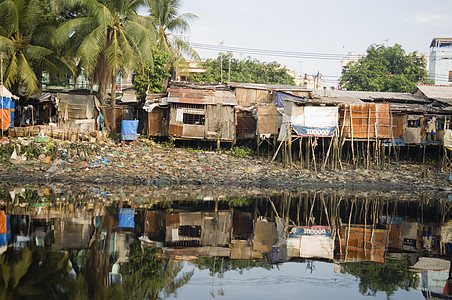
[166,83,237,142]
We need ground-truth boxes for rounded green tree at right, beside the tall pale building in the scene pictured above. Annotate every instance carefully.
[340,44,430,93]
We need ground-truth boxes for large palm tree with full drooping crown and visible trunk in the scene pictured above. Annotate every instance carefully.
[53,0,155,130]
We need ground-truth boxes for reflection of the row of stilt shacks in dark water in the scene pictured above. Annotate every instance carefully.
[138,192,449,263]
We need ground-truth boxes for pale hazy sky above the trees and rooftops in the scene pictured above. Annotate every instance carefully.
[170,0,452,85]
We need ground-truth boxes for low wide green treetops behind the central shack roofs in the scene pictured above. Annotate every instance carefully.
[190,53,295,85]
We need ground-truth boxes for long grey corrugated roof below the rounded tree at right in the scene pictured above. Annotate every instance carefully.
[314,90,431,103]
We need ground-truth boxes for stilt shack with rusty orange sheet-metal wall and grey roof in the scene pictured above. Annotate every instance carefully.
[314,90,445,144]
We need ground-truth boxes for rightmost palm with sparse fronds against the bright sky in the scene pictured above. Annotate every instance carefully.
[147,0,199,79]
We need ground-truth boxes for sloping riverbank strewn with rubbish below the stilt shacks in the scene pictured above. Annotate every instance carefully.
[0,138,452,194]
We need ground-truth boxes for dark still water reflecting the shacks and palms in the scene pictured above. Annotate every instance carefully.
[0,185,452,299]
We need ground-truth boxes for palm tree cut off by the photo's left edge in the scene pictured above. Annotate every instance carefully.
[0,0,72,96]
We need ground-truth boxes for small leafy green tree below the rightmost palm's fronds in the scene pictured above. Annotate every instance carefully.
[133,49,171,101]
